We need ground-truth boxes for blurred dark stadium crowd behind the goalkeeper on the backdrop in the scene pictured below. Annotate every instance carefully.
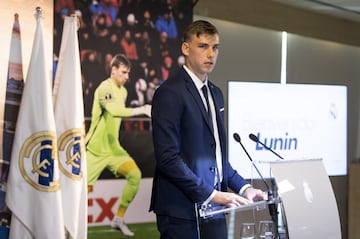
[54,0,193,179]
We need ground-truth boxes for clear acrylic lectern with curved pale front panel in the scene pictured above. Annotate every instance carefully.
[196,159,341,239]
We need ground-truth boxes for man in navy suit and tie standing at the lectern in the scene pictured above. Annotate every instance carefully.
[150,20,264,239]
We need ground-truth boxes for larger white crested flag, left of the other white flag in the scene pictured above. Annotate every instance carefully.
[6,9,65,239]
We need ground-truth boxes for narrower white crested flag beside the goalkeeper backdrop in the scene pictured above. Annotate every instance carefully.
[53,17,87,239]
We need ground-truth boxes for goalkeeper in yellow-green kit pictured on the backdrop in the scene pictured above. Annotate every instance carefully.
[86,54,151,236]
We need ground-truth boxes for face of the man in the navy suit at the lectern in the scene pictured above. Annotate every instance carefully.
[181,34,219,81]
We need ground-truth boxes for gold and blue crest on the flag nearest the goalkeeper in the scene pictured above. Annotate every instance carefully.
[58,129,84,180]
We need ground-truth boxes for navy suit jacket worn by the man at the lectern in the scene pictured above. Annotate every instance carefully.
[150,68,247,220]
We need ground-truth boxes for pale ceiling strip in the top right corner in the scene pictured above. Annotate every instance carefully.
[273,0,360,23]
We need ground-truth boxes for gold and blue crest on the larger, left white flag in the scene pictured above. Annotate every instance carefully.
[19,131,60,192]
